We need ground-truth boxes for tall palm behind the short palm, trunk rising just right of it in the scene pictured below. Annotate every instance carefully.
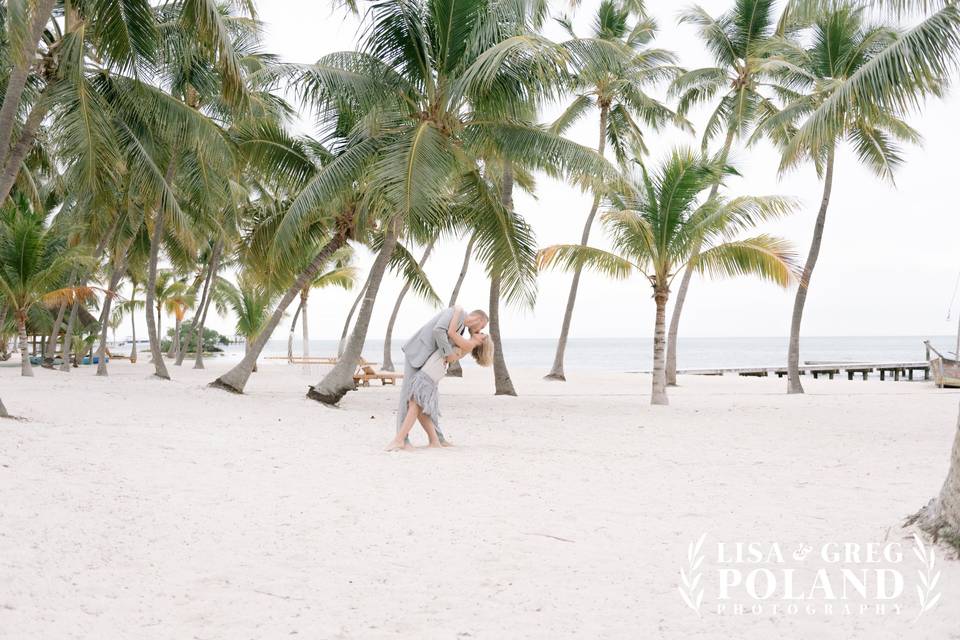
[667,0,790,386]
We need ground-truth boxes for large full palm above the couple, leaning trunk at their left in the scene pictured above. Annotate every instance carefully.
[278,0,611,404]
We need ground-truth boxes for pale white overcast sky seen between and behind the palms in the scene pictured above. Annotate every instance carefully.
[201,0,960,338]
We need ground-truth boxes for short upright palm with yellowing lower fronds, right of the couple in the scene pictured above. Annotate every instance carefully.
[540,149,796,404]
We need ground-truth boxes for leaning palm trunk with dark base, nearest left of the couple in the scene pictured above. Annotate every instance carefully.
[307,221,399,406]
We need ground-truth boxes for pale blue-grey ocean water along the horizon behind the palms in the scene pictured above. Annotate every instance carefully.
[249,336,956,373]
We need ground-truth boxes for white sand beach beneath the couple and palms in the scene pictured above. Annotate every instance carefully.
[0,361,960,640]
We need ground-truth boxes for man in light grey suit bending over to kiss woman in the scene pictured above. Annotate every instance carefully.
[397,307,489,446]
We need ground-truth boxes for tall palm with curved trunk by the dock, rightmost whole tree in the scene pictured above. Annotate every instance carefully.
[754,5,920,393]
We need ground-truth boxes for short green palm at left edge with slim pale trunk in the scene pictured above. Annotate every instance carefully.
[0,197,86,376]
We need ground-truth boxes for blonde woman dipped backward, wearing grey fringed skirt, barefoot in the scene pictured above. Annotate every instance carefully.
[387,309,493,451]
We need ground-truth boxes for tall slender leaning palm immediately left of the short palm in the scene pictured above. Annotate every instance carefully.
[548,0,679,380]
